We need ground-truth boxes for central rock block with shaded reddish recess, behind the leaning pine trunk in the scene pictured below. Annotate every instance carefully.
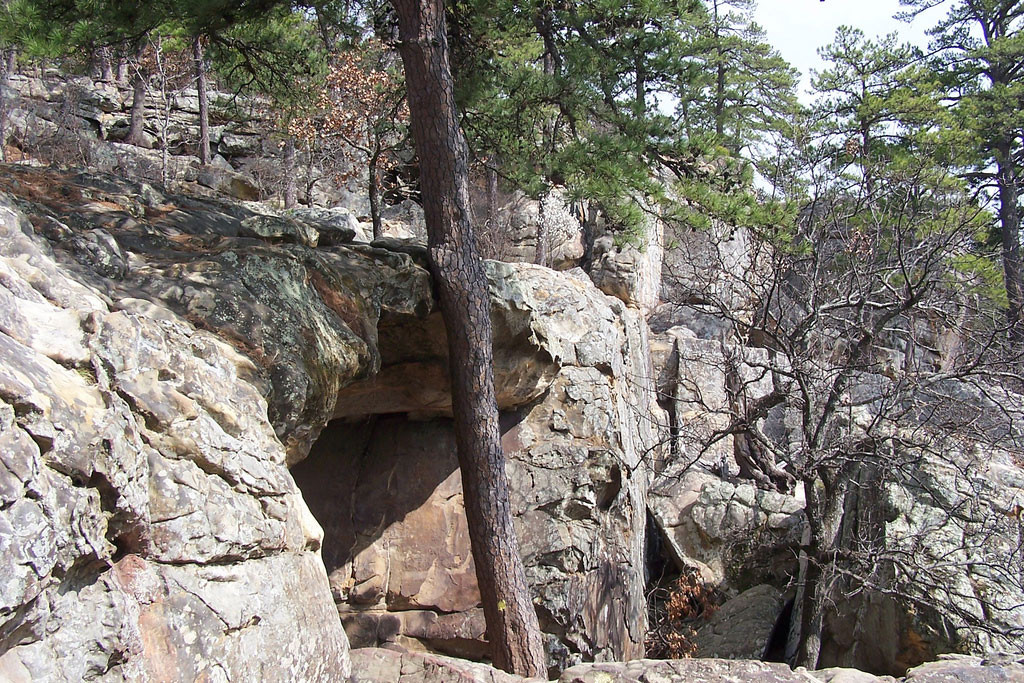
[294,262,657,668]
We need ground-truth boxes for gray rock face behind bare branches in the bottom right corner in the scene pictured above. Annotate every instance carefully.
[822,434,1024,673]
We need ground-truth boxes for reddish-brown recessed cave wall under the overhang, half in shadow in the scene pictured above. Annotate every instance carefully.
[292,414,487,658]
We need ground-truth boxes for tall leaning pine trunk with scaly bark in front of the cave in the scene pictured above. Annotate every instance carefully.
[393,0,546,676]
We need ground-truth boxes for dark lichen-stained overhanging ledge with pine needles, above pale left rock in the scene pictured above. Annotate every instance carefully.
[3,168,433,462]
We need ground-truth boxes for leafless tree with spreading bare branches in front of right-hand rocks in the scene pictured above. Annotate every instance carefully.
[666,148,1024,668]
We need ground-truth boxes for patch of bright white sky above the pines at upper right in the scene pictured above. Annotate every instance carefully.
[756,0,942,99]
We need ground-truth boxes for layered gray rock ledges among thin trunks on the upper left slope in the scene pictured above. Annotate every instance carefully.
[4,73,376,215]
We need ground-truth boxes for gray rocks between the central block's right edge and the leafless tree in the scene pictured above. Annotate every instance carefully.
[648,328,804,592]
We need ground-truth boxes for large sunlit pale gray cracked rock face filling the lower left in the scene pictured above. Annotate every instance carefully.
[0,191,349,681]
